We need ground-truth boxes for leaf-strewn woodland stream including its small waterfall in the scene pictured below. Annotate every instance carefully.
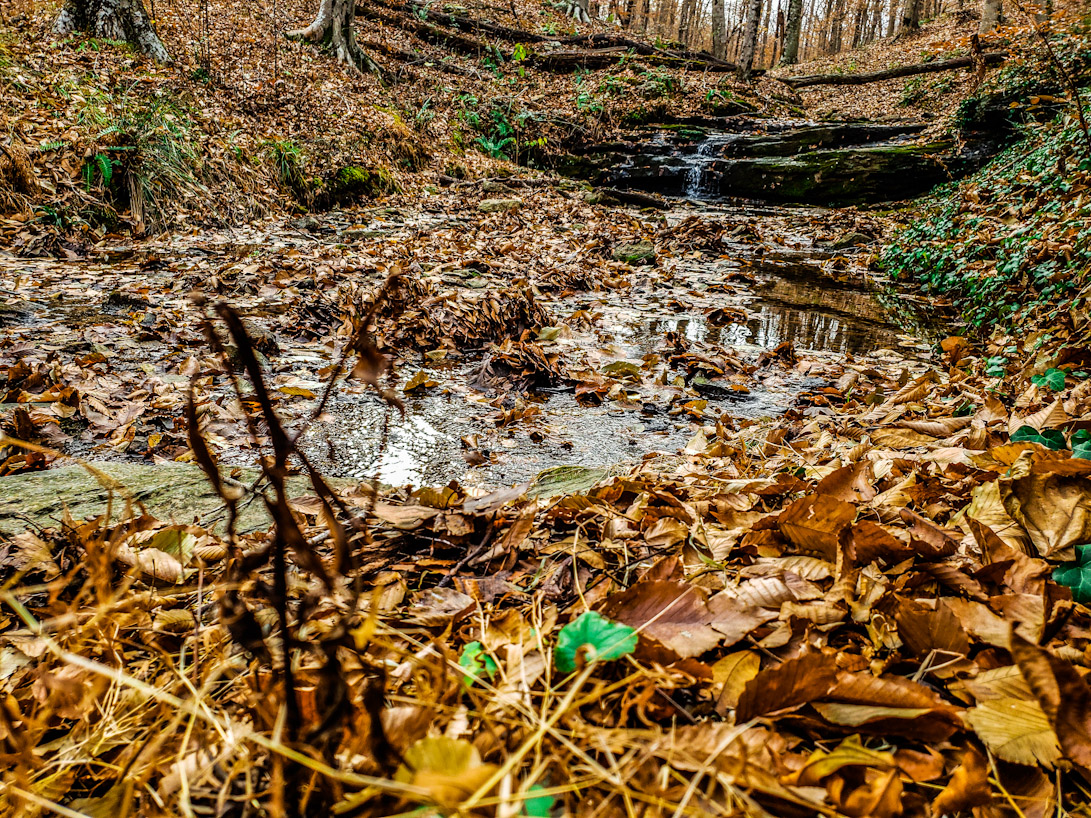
[0,159,930,497]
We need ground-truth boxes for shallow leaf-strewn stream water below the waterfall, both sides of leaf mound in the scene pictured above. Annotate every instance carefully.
[0,202,928,486]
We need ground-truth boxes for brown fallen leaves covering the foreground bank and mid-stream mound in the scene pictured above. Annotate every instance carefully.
[0,187,1091,816]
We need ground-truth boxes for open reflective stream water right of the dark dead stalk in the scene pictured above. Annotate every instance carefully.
[285,203,930,486]
